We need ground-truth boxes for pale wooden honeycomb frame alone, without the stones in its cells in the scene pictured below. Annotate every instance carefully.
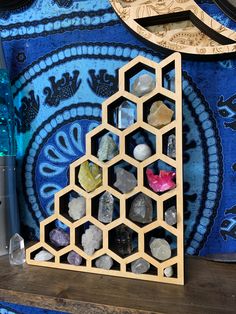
[26,53,184,284]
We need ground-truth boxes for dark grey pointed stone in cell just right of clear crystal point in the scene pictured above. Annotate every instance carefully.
[129,193,153,224]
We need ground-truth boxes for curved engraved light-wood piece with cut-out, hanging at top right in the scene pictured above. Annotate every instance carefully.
[110,0,236,55]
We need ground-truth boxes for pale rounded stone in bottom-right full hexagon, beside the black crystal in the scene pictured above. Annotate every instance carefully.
[149,238,171,261]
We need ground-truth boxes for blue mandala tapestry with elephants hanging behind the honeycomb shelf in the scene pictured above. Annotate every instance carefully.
[0,0,236,255]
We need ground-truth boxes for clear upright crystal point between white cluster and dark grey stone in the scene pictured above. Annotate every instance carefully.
[98,192,114,223]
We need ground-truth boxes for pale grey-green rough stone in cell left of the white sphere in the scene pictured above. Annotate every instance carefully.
[97,134,119,161]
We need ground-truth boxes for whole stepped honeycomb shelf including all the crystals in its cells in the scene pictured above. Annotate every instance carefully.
[26,54,184,284]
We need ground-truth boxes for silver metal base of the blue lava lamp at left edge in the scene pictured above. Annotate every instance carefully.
[0,156,20,256]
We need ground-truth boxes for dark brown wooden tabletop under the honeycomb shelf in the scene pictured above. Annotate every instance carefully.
[0,257,236,314]
